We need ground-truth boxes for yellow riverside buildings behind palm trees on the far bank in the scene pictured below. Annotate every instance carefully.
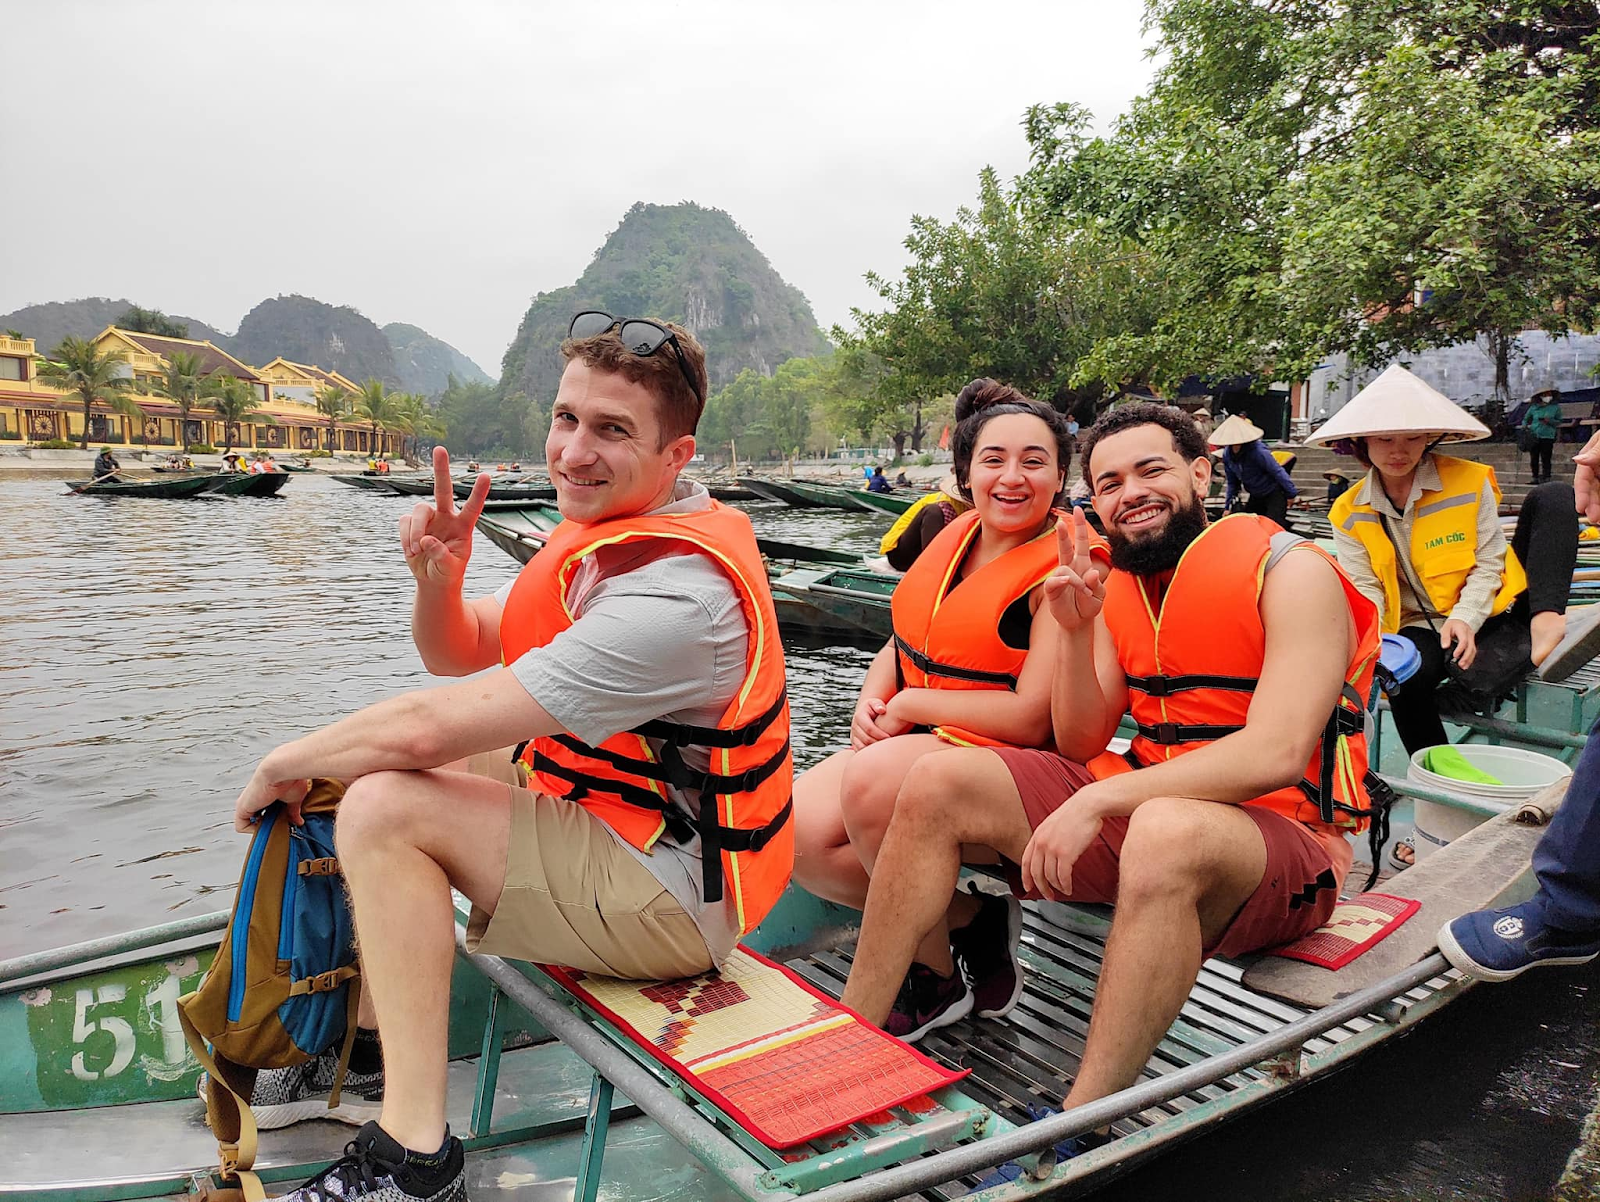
[0,327,400,453]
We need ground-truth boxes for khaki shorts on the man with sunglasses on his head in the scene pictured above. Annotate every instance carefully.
[466,747,712,981]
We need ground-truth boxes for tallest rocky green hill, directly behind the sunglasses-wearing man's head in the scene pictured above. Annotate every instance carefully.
[501,202,827,403]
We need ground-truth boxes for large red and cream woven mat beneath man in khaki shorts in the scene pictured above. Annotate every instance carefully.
[544,948,966,1148]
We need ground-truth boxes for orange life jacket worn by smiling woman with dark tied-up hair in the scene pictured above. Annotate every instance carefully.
[890,509,1104,747]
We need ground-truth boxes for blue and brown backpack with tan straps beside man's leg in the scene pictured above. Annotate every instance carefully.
[178,779,362,1199]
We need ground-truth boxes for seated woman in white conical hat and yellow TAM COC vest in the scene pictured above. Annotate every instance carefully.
[1306,365,1600,771]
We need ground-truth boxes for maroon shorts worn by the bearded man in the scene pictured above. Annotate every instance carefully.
[994,747,1347,956]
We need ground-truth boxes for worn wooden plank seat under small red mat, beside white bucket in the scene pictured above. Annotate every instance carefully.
[1243,778,1570,1008]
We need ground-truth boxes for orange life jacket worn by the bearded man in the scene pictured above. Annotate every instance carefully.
[1090,514,1379,831]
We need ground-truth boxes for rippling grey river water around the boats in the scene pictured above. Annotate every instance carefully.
[0,475,1600,1202]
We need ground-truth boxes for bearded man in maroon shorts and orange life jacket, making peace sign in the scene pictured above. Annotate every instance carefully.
[843,405,1379,1126]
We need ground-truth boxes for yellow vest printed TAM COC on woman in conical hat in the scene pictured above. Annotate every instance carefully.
[1328,455,1528,632]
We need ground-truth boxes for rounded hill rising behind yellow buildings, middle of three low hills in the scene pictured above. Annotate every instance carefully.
[229,294,400,387]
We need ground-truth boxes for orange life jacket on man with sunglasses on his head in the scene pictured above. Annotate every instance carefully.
[499,501,794,933]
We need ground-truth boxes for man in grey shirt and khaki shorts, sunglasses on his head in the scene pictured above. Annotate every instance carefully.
[235,314,792,1197]
